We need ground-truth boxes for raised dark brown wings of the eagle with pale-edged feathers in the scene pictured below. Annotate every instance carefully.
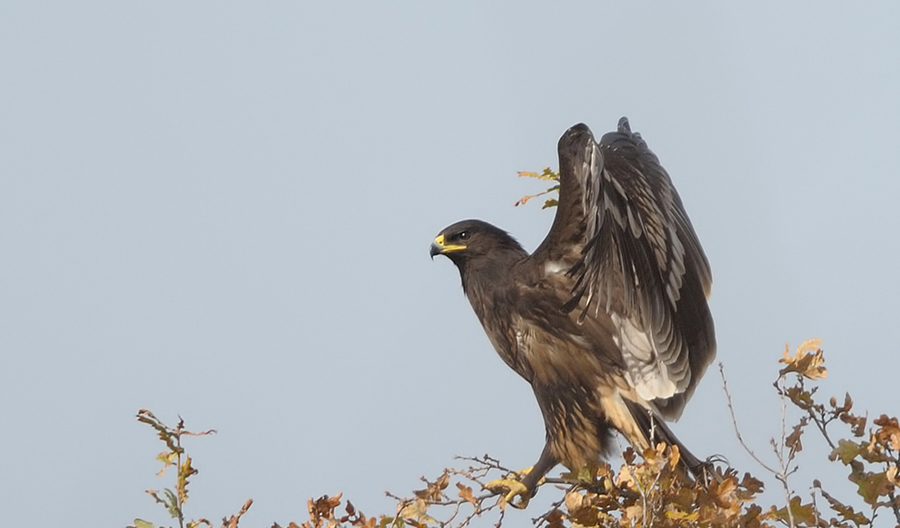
[533,118,715,418]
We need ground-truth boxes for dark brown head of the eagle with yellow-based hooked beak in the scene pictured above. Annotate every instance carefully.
[431,220,525,266]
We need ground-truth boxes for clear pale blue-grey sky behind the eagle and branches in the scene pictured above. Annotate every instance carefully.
[0,0,900,527]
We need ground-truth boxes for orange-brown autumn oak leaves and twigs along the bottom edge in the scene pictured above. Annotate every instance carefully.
[129,340,900,528]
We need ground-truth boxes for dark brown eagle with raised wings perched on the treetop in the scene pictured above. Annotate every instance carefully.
[431,117,716,507]
